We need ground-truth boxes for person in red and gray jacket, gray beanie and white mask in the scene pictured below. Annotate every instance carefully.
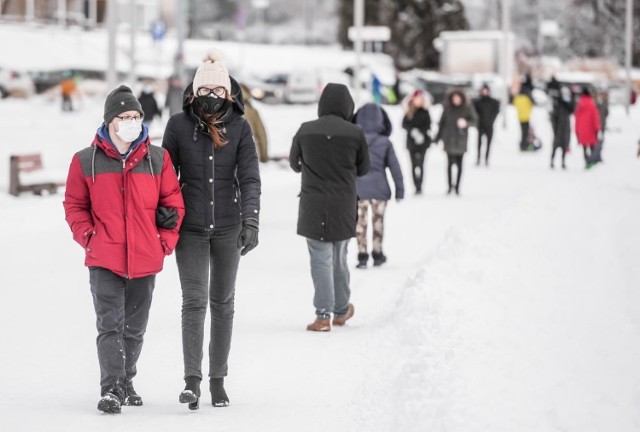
[63,86,184,414]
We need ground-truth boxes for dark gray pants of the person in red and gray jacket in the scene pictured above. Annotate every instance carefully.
[89,267,156,395]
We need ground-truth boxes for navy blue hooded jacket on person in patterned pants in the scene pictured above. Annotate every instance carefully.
[355,103,404,201]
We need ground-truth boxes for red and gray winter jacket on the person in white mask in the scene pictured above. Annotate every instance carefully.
[64,134,184,279]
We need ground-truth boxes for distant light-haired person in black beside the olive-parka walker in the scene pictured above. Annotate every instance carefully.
[402,89,431,195]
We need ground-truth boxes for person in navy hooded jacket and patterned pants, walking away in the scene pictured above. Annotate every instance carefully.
[354,103,404,268]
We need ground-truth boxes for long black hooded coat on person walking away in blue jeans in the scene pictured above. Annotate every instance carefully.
[289,84,369,241]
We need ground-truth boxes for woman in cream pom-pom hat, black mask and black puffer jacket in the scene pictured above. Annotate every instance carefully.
[162,52,261,410]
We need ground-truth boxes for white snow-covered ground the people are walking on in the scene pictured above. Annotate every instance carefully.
[0,101,640,432]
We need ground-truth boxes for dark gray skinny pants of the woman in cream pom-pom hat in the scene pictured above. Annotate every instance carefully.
[176,225,241,379]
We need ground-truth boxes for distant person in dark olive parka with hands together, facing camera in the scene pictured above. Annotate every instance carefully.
[436,89,476,195]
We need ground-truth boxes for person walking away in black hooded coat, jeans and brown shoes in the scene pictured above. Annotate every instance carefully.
[289,83,369,332]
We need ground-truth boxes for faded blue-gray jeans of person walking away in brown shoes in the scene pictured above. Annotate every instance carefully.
[307,238,351,319]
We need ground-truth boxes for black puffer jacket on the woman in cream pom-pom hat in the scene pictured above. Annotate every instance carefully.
[162,78,261,231]
